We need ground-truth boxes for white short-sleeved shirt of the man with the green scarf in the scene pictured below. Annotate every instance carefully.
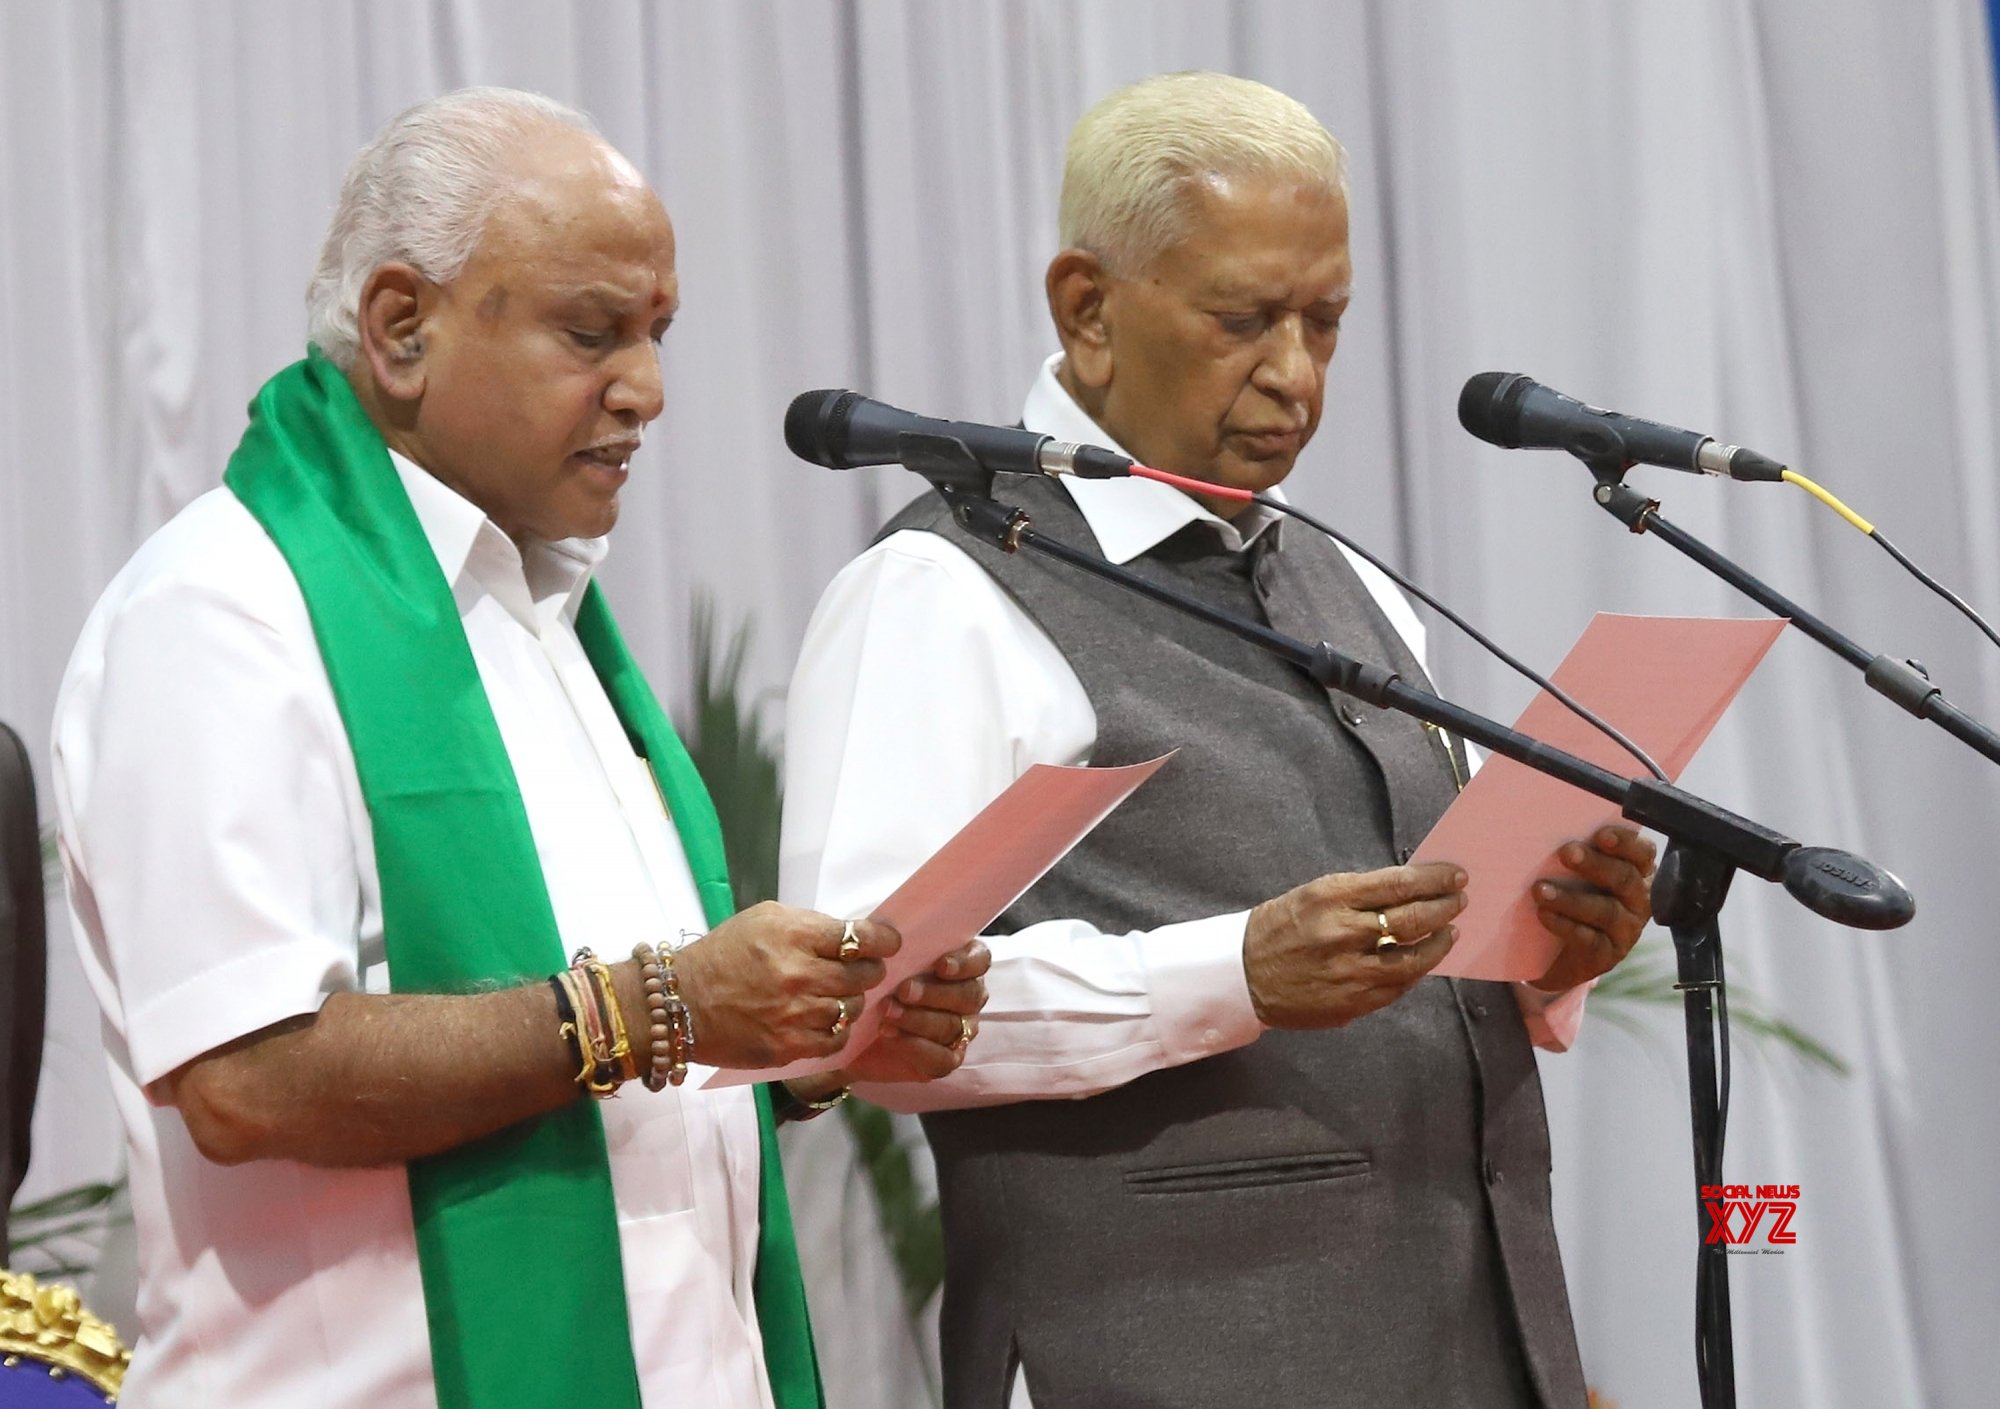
[54,456,772,1409]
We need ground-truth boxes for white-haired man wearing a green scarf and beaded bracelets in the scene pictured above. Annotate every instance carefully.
[54,90,986,1409]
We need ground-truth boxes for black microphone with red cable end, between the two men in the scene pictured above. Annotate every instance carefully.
[784,390,1132,480]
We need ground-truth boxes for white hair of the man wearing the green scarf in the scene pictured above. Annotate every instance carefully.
[306,88,598,370]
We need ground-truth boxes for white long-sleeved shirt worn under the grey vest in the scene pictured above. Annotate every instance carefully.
[778,354,1582,1111]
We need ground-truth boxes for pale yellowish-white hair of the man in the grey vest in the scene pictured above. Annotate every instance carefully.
[1058,72,1348,276]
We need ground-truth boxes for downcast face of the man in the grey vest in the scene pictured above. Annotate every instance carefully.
[1098,176,1354,490]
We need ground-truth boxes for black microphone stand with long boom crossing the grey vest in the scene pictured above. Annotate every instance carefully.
[900,432,1916,1409]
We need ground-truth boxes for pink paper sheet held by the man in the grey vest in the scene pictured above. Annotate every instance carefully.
[1416,612,1786,979]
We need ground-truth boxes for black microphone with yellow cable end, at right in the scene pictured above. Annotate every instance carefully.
[1458,372,1784,480]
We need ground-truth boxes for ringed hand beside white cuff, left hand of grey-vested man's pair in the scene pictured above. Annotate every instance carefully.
[1244,861,1466,1027]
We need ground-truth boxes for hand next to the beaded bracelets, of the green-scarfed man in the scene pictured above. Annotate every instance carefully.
[674,901,902,1069]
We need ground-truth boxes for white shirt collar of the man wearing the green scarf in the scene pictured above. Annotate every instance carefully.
[388,450,610,636]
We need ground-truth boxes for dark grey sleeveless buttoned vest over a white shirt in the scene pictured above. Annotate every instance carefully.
[882,480,1584,1409]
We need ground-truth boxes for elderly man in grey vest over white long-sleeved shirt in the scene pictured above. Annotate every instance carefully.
[780,74,1652,1409]
